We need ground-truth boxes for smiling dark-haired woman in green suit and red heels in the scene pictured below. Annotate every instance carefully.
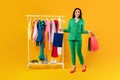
[59,8,93,73]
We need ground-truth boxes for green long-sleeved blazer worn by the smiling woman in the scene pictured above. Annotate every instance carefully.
[64,18,88,40]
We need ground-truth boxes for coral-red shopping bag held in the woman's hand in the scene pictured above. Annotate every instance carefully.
[90,36,99,51]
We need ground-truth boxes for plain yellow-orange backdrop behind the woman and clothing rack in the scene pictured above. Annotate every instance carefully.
[0,0,120,80]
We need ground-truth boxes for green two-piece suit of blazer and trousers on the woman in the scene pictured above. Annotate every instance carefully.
[64,18,88,65]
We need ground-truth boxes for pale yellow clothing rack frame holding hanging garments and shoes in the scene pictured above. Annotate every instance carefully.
[26,15,65,70]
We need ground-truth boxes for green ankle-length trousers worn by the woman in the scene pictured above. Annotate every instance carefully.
[69,40,84,65]
